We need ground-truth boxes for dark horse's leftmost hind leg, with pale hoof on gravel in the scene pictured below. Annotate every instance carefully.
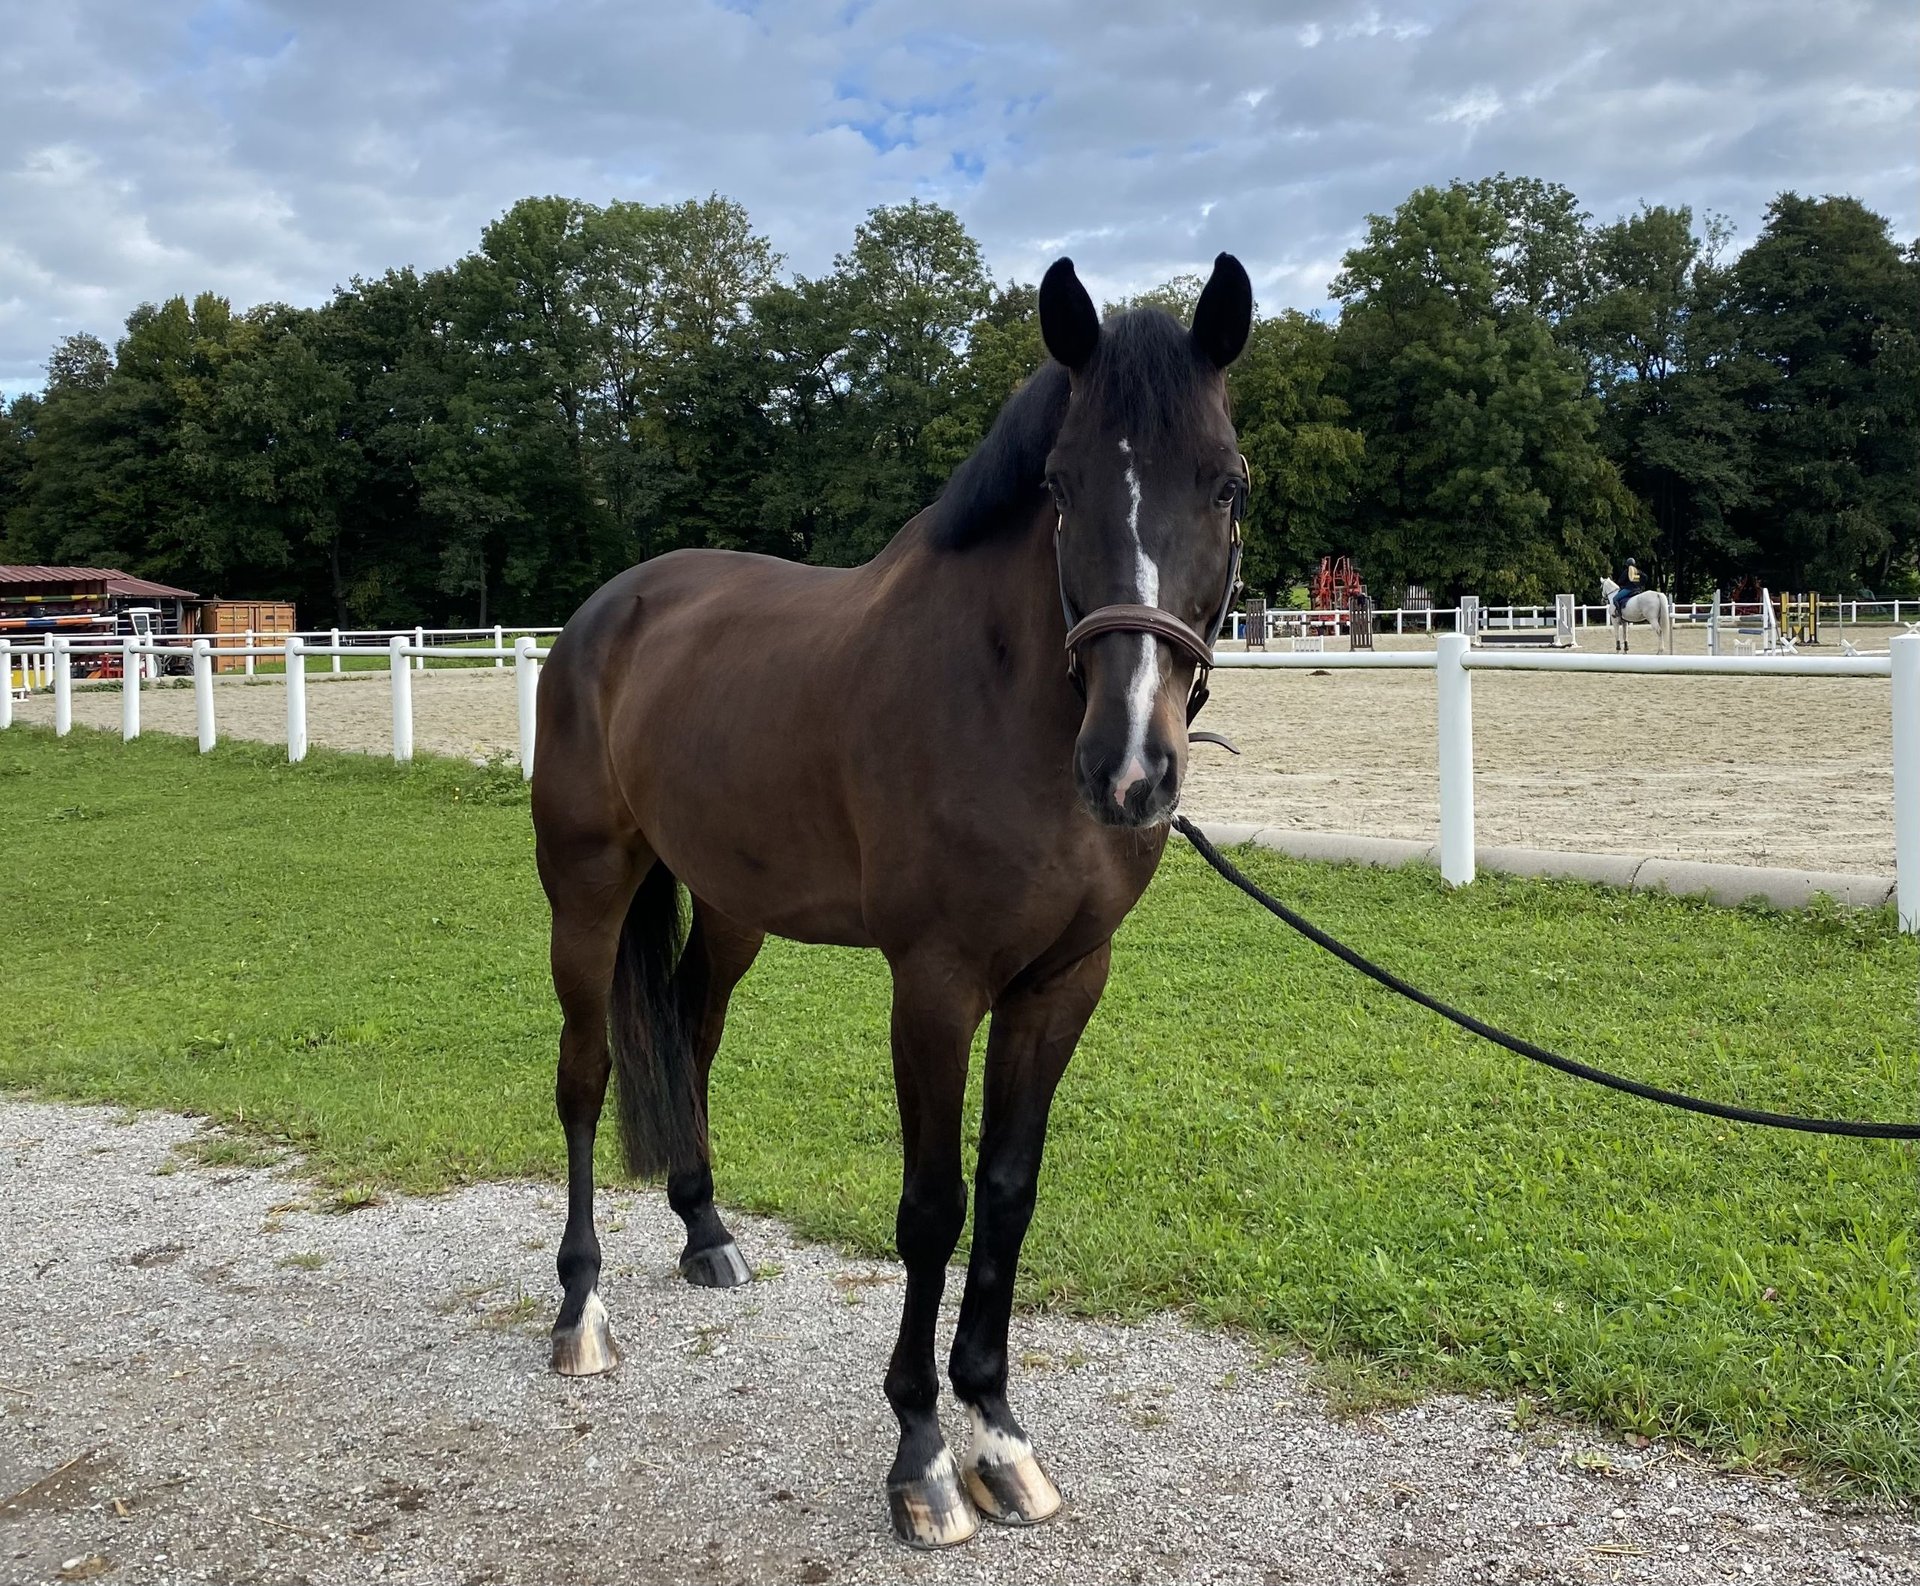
[540,845,645,1377]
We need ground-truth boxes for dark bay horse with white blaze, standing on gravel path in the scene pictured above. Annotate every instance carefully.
[534,253,1252,1546]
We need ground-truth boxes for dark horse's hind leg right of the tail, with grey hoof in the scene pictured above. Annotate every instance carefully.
[666,899,766,1288]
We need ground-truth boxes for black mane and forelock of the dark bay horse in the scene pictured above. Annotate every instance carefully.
[933,309,1212,551]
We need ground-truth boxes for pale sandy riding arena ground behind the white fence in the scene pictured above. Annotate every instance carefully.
[19,628,1893,874]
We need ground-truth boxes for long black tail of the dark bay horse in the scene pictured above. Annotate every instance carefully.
[609,862,707,1177]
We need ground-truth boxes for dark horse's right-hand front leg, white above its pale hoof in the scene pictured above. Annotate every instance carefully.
[948,943,1110,1525]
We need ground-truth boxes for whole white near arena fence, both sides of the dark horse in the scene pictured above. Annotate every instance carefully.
[0,630,1920,933]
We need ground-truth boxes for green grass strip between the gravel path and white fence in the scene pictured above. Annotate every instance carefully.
[0,730,1920,1498]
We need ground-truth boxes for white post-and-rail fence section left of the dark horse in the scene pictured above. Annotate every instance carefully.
[0,628,559,778]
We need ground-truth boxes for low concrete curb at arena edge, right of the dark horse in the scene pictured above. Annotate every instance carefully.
[1196,820,1893,908]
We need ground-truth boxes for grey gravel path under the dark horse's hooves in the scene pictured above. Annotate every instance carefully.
[0,1100,1920,1586]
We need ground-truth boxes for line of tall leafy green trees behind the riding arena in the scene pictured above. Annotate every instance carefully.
[0,175,1920,626]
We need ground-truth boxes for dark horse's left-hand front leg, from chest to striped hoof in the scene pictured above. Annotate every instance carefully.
[885,962,987,1548]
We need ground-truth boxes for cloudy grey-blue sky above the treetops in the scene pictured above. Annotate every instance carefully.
[0,0,1920,390]
